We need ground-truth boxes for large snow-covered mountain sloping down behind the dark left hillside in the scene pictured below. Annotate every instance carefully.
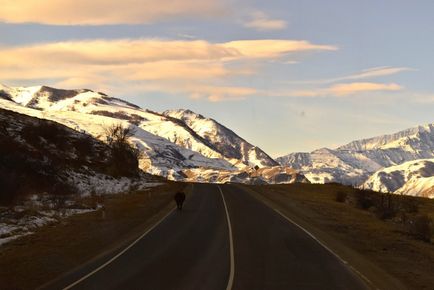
[0,86,284,180]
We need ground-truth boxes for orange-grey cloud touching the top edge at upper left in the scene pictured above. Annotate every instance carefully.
[0,0,227,25]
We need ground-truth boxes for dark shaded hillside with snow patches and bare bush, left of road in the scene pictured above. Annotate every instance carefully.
[0,109,156,256]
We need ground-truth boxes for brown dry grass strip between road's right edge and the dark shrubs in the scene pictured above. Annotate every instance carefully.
[243,184,434,290]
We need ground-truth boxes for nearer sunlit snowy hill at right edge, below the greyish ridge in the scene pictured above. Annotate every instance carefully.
[362,159,434,198]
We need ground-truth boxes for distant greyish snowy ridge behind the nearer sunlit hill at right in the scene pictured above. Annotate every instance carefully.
[277,124,434,185]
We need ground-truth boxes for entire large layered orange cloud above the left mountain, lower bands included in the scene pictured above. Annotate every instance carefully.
[0,39,336,102]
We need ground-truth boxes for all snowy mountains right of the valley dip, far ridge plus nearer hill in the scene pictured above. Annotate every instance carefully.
[276,120,434,197]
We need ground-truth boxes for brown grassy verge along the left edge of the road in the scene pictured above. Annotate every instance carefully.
[0,183,185,289]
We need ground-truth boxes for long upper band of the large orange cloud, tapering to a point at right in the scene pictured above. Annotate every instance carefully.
[0,39,337,65]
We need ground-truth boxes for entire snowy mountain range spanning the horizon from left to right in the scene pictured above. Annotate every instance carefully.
[0,85,434,197]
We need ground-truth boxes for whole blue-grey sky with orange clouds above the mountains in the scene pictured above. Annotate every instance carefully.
[0,0,434,157]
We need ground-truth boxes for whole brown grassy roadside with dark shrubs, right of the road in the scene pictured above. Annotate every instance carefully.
[241,183,434,290]
